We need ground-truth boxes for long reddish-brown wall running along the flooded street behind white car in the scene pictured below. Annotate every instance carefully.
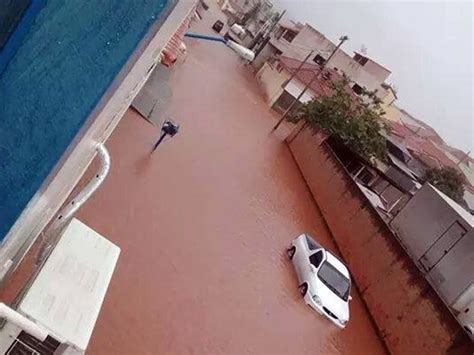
[289,127,468,354]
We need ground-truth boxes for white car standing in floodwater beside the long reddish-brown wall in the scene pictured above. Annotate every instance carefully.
[287,234,352,328]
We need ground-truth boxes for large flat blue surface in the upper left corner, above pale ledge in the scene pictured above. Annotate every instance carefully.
[0,0,170,240]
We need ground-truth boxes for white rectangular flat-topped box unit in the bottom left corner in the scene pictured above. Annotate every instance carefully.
[0,219,120,354]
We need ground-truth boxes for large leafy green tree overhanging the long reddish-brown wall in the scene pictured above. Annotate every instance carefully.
[289,78,387,161]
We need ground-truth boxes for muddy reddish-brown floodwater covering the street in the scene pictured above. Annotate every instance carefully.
[74,7,384,354]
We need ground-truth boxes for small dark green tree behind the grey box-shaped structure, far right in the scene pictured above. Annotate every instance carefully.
[424,166,464,203]
